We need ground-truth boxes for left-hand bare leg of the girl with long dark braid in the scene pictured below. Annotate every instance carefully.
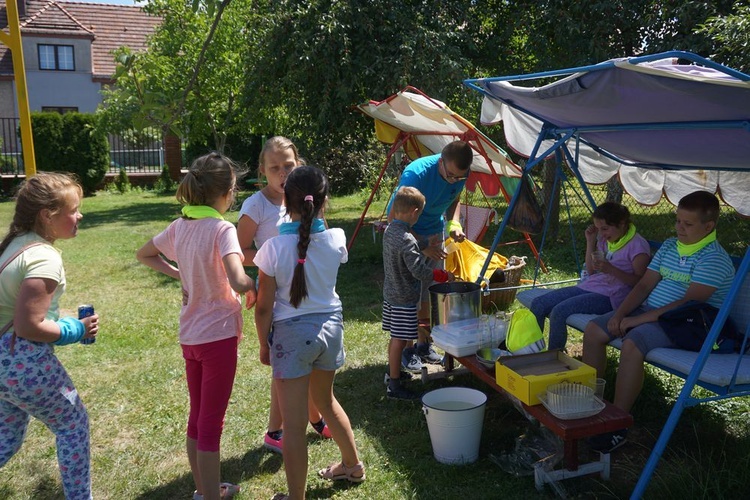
[274,375,310,500]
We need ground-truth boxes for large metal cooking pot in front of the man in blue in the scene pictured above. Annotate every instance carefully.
[429,281,482,326]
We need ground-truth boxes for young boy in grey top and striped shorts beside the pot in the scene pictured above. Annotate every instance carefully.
[383,186,454,400]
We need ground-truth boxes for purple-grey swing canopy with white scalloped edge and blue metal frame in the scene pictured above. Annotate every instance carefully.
[464,51,750,498]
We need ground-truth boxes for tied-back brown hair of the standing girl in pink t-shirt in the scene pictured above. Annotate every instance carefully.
[177,152,237,205]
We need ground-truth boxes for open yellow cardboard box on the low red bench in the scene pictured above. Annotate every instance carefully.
[495,350,596,406]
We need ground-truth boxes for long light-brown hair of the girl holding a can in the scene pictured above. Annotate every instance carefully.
[0,172,83,253]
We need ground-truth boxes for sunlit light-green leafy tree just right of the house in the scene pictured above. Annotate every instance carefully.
[96,0,252,151]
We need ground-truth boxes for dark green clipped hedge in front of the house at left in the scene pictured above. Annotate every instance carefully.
[31,113,109,195]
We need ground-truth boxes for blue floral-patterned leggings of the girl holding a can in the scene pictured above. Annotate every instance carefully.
[0,333,91,500]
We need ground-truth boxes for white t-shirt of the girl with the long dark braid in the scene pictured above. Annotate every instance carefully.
[255,228,349,321]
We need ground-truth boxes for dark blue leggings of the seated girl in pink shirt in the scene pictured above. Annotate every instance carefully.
[529,286,612,349]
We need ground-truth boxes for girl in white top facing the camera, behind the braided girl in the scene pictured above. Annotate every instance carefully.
[237,136,331,453]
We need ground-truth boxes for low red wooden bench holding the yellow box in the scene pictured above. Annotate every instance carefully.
[445,353,633,488]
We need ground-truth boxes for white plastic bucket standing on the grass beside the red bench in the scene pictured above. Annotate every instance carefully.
[422,387,487,464]
